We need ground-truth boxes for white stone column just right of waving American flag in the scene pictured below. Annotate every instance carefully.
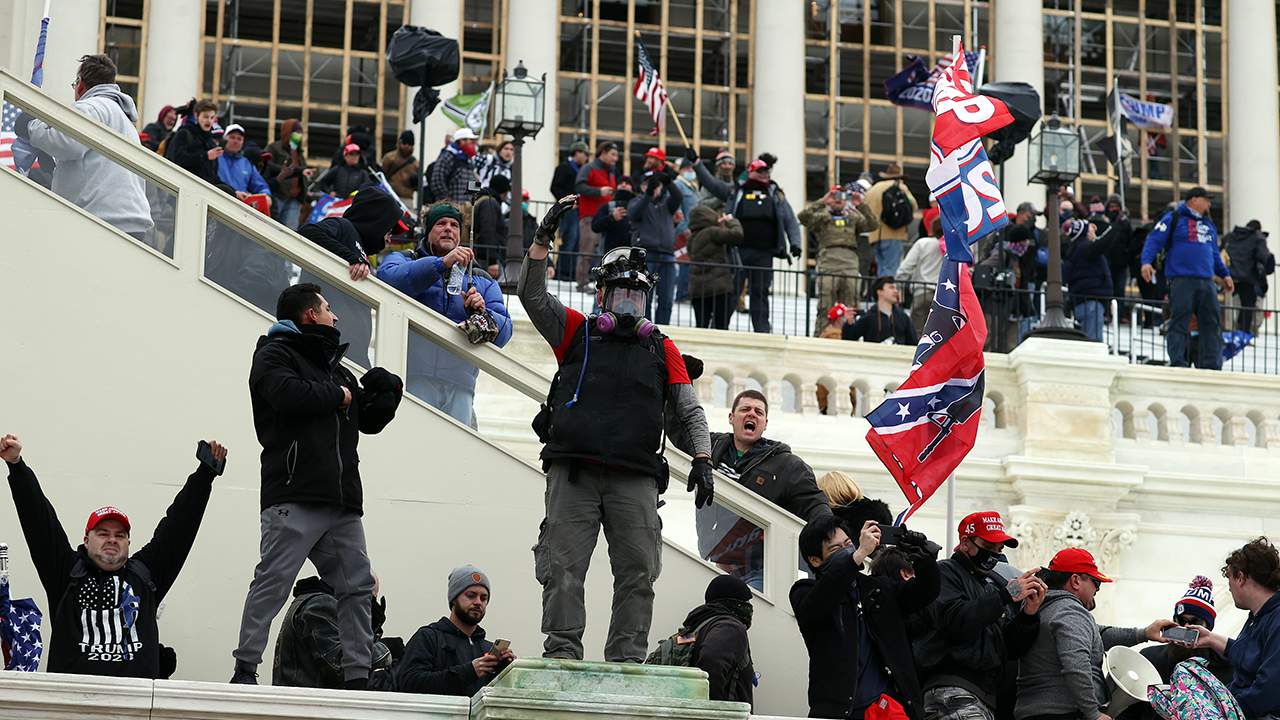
[745,1,809,213]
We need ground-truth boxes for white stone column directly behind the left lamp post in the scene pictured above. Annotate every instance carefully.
[507,0,561,200]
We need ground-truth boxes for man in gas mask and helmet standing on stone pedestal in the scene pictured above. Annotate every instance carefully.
[517,195,713,662]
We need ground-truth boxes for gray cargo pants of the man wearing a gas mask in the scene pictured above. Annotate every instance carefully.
[534,460,662,662]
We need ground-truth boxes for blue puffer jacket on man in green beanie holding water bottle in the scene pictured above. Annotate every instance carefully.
[378,252,512,391]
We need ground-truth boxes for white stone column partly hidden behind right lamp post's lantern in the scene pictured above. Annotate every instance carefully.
[986,0,1039,211]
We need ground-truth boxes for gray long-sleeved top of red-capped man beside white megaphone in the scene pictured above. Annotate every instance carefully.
[1014,591,1147,720]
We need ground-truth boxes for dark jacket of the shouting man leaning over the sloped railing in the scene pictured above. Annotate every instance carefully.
[712,433,831,521]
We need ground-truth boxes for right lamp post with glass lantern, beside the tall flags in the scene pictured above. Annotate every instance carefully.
[1027,115,1088,340]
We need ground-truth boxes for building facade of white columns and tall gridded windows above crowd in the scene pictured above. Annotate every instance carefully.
[0,0,1280,237]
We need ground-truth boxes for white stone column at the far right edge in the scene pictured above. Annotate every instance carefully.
[1225,0,1280,252]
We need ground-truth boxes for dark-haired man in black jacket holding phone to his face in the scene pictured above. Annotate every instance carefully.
[790,514,938,720]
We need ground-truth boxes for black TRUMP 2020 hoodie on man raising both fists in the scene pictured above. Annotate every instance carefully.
[9,460,214,679]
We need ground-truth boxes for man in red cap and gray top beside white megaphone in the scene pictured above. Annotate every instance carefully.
[1014,547,1175,720]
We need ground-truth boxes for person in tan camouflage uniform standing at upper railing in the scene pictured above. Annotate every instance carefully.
[800,184,879,334]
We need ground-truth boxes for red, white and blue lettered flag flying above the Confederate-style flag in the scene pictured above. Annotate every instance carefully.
[924,42,1014,263]
